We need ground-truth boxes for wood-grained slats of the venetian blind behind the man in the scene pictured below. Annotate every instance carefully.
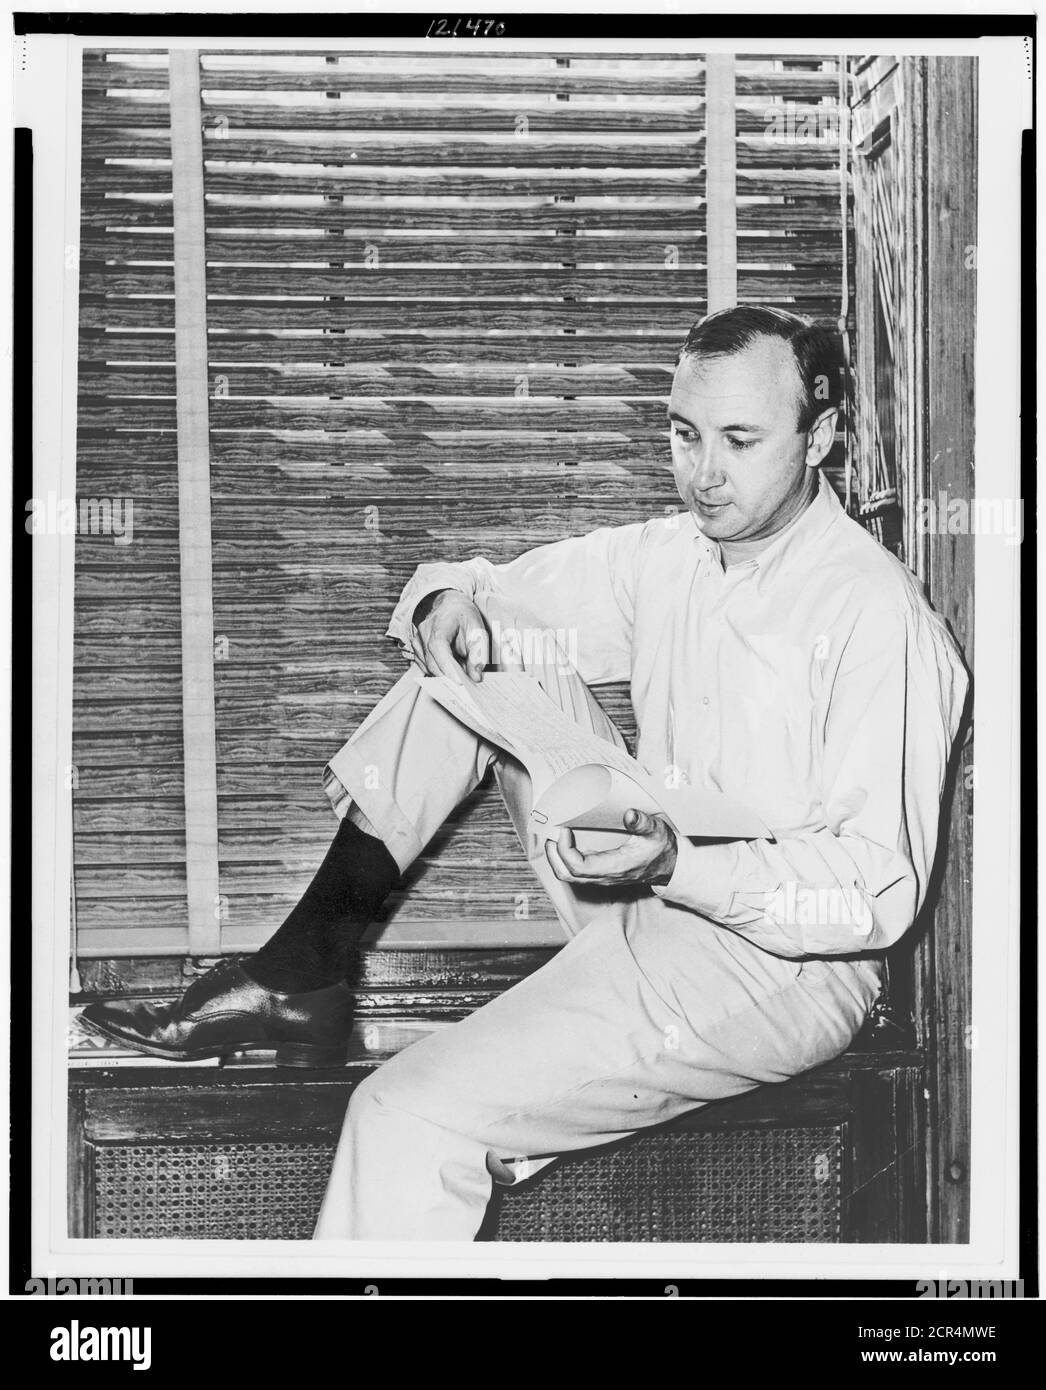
[75,49,845,955]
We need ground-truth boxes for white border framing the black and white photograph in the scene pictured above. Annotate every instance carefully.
[13,16,1031,1293]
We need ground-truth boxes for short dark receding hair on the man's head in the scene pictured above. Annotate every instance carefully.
[676,304,843,434]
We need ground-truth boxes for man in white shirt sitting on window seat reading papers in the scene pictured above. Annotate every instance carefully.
[89,306,967,1240]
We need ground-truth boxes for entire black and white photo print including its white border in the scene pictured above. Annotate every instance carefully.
[13,6,1033,1312]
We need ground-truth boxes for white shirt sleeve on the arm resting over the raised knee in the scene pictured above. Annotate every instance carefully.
[388,523,646,685]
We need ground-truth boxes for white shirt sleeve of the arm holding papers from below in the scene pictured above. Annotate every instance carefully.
[653,605,968,958]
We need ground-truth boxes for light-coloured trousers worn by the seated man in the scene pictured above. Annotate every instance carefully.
[315,599,879,1240]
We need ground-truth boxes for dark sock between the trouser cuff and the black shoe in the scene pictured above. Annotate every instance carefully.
[243,820,400,994]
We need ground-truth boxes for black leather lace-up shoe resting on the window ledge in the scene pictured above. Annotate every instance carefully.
[81,960,353,1066]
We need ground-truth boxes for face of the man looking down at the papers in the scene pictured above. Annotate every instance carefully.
[668,338,831,543]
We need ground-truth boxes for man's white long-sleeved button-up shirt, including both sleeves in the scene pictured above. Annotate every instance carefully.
[389,477,967,958]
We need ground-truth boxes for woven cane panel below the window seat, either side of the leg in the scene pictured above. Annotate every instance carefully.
[92,1127,840,1241]
